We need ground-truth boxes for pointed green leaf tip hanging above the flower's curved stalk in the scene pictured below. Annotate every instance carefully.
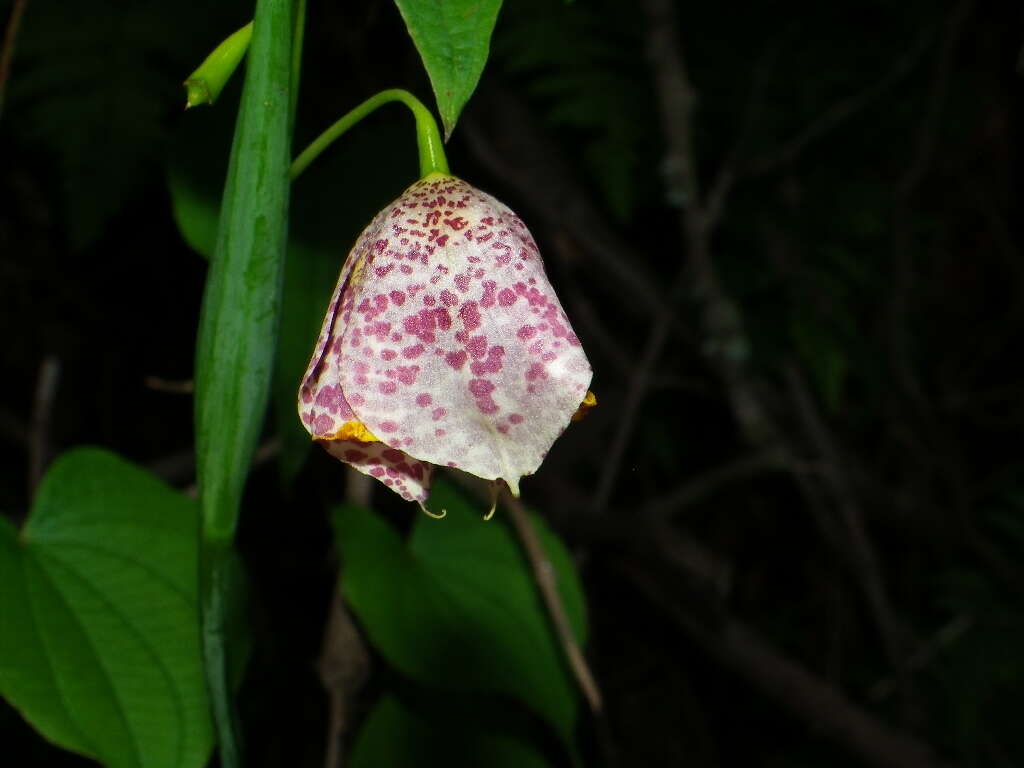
[395,0,502,141]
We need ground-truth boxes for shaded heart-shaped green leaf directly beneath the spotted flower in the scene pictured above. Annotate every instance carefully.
[335,482,585,749]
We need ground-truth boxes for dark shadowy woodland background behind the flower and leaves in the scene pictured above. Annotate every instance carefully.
[0,0,1024,768]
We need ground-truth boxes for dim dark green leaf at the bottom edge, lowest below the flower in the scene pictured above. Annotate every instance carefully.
[349,693,550,768]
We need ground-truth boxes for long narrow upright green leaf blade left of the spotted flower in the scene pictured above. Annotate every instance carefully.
[196,0,294,768]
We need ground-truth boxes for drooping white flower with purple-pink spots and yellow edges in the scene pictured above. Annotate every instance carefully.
[299,173,595,510]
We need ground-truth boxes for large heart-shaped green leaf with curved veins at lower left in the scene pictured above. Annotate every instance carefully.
[0,449,213,768]
